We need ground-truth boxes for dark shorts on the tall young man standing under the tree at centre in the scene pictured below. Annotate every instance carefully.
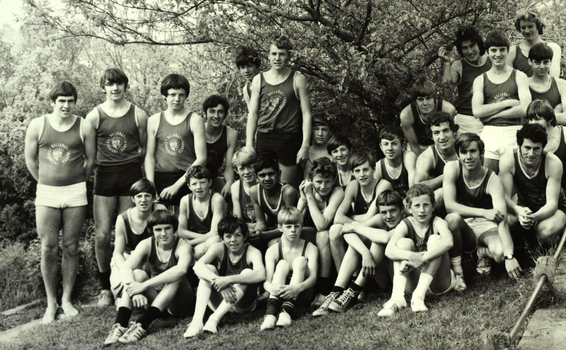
[256,132,303,166]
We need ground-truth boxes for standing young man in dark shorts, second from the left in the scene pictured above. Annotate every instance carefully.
[86,68,147,306]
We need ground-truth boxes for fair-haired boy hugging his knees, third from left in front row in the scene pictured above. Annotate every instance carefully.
[260,207,318,330]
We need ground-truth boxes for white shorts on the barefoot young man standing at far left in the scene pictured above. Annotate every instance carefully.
[35,181,88,209]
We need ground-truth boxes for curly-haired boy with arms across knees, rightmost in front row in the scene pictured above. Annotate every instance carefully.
[377,184,456,317]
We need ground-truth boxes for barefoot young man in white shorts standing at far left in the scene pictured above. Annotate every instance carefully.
[25,81,96,323]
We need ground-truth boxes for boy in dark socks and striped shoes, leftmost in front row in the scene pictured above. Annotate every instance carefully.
[104,210,194,345]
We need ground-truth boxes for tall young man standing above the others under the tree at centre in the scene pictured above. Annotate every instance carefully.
[246,37,312,186]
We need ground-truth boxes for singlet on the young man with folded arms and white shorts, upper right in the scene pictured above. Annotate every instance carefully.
[482,69,525,126]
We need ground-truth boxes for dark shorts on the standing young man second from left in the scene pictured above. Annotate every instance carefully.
[94,162,143,197]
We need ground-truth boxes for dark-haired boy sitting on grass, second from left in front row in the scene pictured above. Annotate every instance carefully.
[184,216,265,338]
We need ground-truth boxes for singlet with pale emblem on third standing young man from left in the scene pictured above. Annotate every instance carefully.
[155,112,197,173]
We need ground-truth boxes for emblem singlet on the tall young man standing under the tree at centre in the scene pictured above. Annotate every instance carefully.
[257,71,303,134]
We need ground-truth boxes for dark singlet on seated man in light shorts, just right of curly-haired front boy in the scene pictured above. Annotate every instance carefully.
[455,162,495,209]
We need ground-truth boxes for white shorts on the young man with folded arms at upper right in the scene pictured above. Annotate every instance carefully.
[480,125,523,160]
